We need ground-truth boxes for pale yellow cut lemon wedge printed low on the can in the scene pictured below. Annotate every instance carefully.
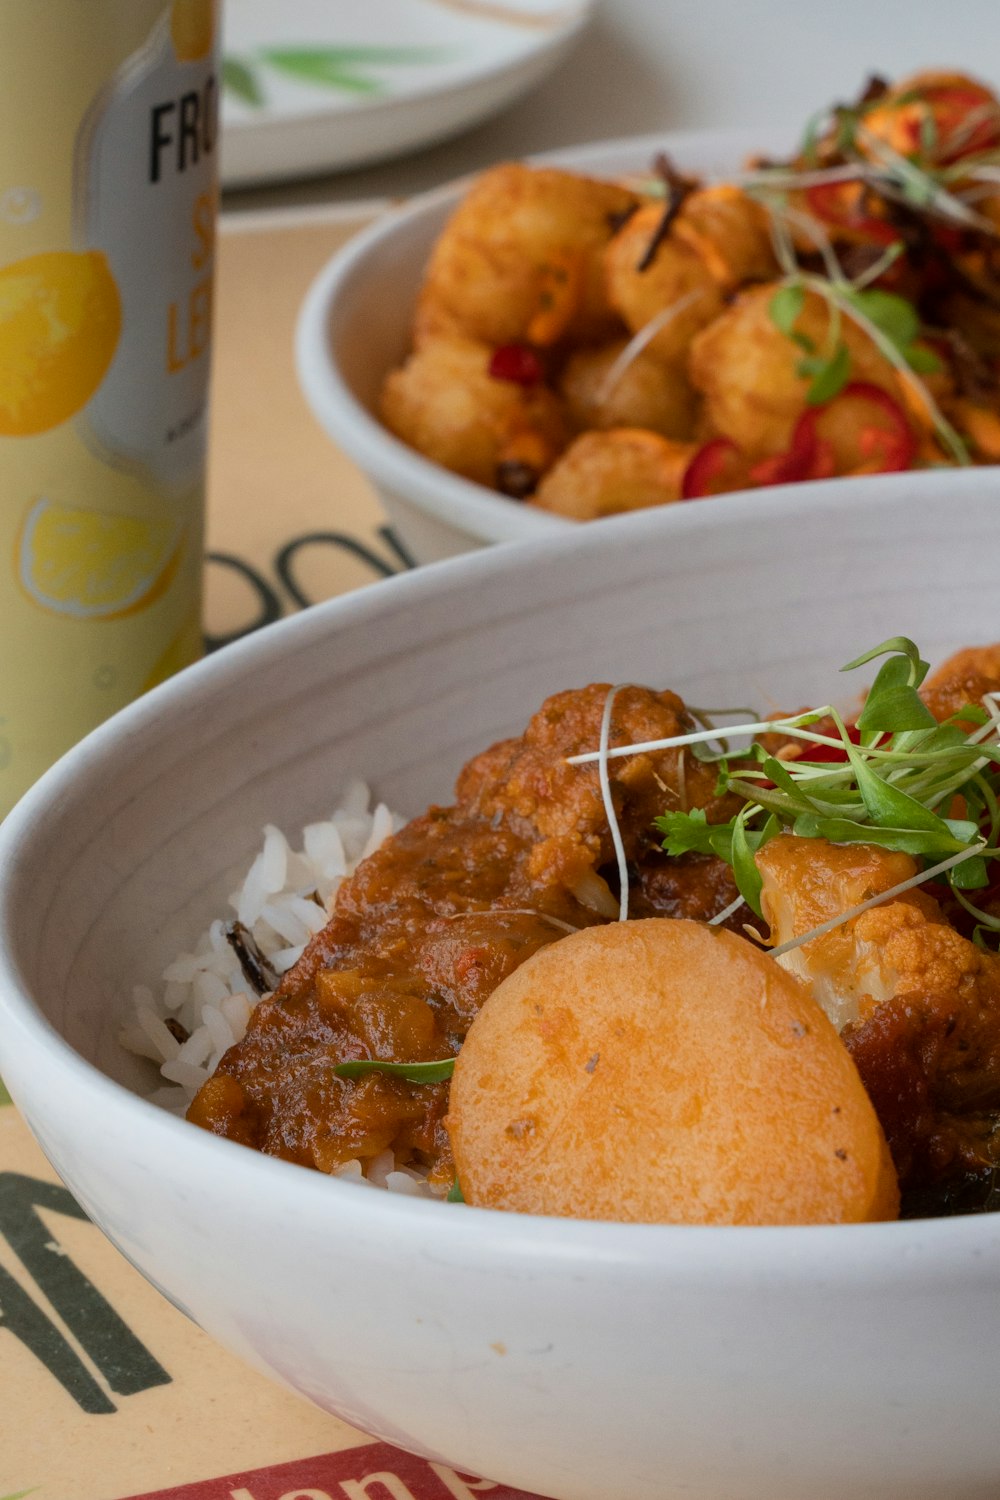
[16,500,183,620]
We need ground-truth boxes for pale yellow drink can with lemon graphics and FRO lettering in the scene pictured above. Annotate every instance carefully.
[0,0,219,818]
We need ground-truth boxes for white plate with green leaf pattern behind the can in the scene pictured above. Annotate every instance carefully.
[222,0,592,188]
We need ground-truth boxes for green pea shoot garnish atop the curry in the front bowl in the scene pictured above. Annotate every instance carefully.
[573,636,1000,953]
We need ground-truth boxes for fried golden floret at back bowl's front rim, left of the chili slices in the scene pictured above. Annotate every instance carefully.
[532,428,696,521]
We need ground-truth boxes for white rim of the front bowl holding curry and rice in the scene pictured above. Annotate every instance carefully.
[0,468,1000,1286]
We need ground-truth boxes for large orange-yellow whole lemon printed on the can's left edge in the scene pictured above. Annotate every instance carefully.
[0,251,121,438]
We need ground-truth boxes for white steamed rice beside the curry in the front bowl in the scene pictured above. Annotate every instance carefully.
[121,782,443,1196]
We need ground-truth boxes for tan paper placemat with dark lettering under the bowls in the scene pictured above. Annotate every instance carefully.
[0,202,531,1500]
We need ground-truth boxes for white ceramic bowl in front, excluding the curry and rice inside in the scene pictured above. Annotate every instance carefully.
[0,470,1000,1500]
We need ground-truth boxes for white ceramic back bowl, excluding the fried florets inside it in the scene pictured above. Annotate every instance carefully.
[297,131,795,563]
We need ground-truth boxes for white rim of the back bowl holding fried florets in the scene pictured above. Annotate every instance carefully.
[295,126,815,542]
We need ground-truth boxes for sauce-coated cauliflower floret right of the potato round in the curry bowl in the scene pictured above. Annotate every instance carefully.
[757,836,1000,1182]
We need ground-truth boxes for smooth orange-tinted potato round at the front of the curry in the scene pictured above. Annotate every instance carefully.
[448,918,898,1224]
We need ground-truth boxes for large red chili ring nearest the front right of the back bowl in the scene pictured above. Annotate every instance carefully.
[792,380,918,477]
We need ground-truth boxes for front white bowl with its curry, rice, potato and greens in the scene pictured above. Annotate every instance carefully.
[0,470,1000,1500]
